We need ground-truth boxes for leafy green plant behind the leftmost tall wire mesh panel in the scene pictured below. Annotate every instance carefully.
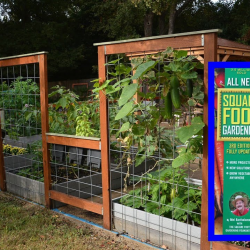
[0,77,41,139]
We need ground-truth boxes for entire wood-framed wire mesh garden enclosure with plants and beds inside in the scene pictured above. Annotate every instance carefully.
[0,30,250,249]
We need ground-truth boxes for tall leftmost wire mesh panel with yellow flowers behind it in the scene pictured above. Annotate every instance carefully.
[0,63,44,203]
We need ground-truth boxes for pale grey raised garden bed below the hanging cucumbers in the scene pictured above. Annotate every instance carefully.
[112,198,201,250]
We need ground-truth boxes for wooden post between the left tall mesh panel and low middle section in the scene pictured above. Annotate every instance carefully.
[39,54,51,208]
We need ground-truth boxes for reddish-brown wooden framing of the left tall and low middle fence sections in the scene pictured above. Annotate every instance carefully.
[0,52,111,229]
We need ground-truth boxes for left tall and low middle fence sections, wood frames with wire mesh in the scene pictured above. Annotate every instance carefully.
[0,52,110,229]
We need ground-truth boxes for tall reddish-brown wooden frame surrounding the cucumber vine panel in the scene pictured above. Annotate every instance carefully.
[94,29,250,250]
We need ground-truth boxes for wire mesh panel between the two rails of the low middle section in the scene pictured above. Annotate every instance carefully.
[50,144,102,206]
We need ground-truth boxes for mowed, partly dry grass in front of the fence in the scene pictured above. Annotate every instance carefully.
[0,191,133,250]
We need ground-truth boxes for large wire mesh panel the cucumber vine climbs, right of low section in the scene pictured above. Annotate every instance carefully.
[106,51,203,250]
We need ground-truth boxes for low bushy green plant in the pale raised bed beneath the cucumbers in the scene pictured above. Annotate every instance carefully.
[120,166,201,225]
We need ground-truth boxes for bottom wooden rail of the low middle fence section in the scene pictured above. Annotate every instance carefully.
[49,190,103,215]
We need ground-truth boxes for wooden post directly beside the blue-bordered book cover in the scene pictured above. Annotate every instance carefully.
[200,33,217,250]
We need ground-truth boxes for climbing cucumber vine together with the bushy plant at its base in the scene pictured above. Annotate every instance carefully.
[94,48,204,224]
